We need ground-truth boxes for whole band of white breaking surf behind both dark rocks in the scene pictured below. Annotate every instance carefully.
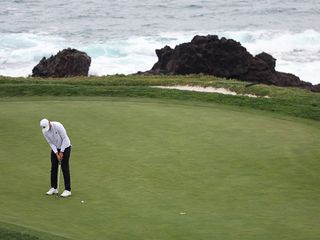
[0,30,320,84]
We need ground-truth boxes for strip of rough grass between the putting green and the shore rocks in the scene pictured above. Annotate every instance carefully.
[0,75,320,120]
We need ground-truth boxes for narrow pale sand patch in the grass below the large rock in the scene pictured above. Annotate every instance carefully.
[154,85,270,98]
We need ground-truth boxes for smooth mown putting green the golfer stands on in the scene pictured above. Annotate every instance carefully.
[0,98,320,240]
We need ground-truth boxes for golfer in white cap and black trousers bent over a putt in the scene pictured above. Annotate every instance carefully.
[40,118,71,197]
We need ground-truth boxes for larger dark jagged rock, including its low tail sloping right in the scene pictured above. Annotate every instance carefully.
[145,35,319,91]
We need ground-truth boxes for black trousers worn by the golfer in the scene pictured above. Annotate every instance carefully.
[51,146,71,191]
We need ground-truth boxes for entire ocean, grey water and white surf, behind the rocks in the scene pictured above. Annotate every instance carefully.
[0,0,320,84]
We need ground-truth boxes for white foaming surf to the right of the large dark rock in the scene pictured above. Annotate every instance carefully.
[222,29,320,84]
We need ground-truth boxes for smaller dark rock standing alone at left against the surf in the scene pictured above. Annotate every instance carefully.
[32,48,91,77]
